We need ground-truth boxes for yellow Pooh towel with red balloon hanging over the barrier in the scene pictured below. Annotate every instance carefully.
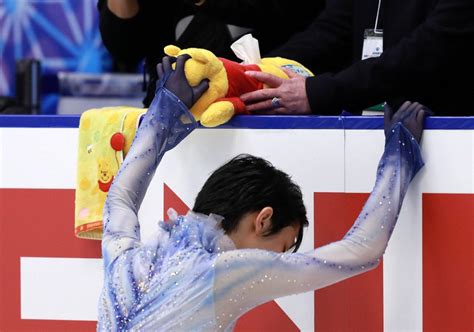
[75,106,146,240]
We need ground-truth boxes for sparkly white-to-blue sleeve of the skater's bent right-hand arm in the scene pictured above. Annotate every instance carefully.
[214,123,423,322]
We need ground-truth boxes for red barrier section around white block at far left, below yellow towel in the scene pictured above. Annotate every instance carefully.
[0,189,101,331]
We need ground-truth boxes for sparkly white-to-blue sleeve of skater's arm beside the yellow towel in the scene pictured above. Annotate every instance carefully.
[102,87,197,269]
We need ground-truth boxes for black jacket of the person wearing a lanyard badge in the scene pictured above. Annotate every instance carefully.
[272,0,474,115]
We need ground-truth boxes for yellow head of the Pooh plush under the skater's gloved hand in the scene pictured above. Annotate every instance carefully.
[165,45,229,120]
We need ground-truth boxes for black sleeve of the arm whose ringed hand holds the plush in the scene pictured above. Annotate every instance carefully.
[306,0,474,114]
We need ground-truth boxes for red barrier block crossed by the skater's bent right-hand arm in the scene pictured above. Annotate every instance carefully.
[314,193,383,332]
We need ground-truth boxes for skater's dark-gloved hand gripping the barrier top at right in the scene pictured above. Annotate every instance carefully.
[384,101,431,143]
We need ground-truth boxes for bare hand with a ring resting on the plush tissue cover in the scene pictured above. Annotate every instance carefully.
[240,69,311,115]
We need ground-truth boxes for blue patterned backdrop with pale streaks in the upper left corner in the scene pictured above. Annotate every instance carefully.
[0,0,112,114]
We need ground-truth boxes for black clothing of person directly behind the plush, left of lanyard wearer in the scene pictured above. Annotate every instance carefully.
[98,0,324,106]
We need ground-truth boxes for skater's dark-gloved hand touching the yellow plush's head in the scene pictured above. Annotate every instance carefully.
[156,54,209,108]
